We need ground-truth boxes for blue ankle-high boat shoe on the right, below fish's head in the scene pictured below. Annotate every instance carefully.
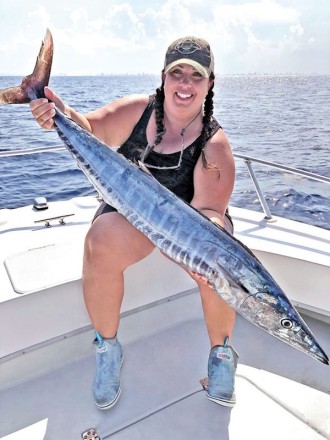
[206,337,238,407]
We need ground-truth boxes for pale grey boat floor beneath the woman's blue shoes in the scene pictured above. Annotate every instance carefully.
[0,292,330,440]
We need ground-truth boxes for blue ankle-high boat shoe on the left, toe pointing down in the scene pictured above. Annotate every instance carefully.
[93,332,123,409]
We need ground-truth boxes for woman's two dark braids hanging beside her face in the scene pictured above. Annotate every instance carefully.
[154,73,216,169]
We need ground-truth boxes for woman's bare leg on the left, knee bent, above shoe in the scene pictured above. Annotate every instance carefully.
[83,212,154,338]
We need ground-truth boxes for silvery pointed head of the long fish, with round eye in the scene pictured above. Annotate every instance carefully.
[239,286,329,365]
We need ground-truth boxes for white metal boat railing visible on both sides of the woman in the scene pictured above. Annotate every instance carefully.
[0,145,330,221]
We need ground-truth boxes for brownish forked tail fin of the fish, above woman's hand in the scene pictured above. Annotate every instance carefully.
[0,29,53,104]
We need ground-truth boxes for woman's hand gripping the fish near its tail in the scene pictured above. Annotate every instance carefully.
[30,87,66,130]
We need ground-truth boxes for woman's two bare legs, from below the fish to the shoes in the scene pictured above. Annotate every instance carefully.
[83,212,236,347]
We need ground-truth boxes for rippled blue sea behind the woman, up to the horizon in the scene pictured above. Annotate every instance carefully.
[0,75,330,229]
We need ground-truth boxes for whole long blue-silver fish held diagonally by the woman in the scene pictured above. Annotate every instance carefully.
[0,30,329,364]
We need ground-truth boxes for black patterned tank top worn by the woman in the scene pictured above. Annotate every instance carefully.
[118,95,221,203]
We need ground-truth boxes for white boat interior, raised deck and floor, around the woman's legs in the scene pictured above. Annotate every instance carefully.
[0,198,330,440]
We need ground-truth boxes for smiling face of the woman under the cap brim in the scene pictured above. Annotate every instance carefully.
[164,64,213,113]
